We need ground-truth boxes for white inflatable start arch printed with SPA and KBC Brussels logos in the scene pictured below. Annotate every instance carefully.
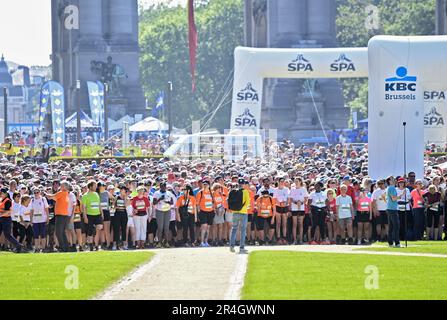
[230,36,447,179]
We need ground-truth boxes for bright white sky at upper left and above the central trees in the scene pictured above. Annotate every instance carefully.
[0,0,187,66]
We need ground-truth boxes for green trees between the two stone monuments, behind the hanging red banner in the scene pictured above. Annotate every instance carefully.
[140,0,244,129]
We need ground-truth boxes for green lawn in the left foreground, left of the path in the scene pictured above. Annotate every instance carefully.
[0,252,153,300]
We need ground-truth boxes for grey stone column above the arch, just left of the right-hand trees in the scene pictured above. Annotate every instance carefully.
[307,0,336,47]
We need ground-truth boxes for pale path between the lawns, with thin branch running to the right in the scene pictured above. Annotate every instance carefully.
[97,245,447,300]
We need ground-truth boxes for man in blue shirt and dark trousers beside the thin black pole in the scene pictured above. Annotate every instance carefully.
[386,176,400,248]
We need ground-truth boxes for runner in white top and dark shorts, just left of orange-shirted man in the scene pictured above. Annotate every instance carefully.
[31,188,50,253]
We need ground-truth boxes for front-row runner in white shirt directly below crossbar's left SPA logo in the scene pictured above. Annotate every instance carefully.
[289,178,309,244]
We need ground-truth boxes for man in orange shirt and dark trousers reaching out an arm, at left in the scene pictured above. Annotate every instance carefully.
[46,181,70,252]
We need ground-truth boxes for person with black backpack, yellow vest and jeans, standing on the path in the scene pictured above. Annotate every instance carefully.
[228,179,250,254]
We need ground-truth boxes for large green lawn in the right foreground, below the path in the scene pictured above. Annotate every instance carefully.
[242,251,447,300]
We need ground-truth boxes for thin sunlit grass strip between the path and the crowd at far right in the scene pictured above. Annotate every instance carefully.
[355,241,447,255]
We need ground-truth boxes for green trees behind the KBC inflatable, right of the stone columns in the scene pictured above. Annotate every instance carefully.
[337,0,436,119]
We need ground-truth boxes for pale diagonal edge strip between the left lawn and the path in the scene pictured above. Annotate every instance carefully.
[94,254,161,300]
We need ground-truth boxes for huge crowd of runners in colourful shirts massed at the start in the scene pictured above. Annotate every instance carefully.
[0,141,447,253]
